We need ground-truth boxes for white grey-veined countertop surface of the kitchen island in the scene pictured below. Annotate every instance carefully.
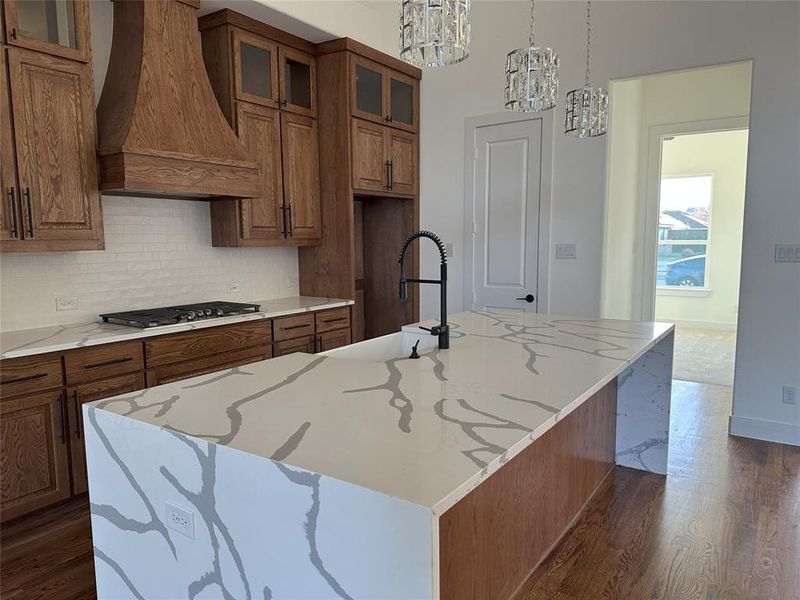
[90,311,673,514]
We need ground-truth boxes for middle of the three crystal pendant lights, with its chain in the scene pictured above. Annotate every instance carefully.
[505,0,559,112]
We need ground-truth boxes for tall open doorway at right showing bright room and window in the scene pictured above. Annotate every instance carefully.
[603,62,752,386]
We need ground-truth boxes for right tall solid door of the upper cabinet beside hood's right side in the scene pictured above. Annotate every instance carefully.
[281,112,322,240]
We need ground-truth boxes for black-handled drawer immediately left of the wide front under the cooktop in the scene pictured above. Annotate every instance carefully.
[64,342,144,385]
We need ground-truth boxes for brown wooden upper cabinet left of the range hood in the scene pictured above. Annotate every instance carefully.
[0,1,103,252]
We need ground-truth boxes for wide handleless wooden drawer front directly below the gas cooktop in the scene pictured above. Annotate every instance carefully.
[144,320,272,369]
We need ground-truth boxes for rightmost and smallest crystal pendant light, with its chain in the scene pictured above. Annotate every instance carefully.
[564,0,608,139]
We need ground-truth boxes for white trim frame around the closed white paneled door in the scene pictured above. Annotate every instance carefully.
[463,111,553,313]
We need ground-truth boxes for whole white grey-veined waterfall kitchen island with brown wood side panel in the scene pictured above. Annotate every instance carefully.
[84,311,673,600]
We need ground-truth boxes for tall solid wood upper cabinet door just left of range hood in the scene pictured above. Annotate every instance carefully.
[8,48,103,250]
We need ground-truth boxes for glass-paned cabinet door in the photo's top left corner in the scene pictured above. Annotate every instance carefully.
[3,0,91,62]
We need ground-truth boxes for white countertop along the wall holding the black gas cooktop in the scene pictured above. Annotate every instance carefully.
[0,296,353,358]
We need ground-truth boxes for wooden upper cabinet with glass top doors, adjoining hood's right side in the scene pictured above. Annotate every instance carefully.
[200,9,322,246]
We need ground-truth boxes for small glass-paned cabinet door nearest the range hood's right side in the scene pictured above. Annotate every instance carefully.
[231,29,278,107]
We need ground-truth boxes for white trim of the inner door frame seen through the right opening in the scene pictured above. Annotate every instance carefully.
[633,115,750,321]
